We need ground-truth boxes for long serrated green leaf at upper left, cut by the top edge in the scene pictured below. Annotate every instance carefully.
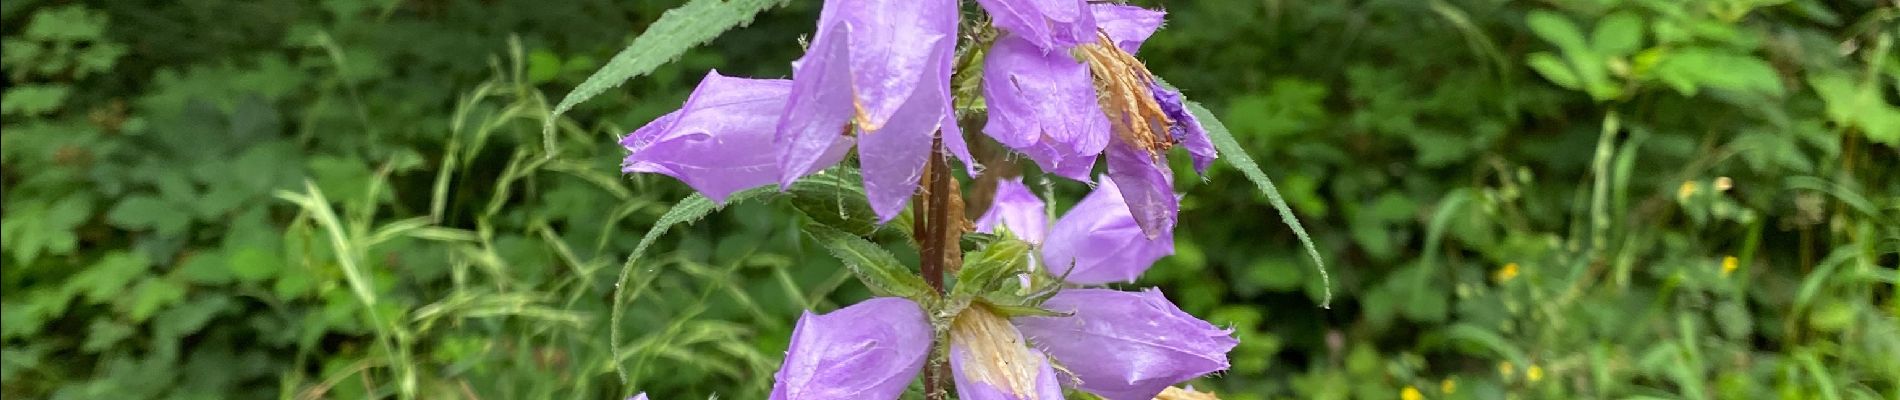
[542,0,787,154]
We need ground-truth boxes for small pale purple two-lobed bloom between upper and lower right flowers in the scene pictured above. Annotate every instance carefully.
[977,178,1174,284]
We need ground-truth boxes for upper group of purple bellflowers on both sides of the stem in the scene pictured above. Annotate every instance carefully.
[621,0,1214,237]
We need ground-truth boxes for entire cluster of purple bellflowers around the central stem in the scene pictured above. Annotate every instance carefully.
[621,0,1237,400]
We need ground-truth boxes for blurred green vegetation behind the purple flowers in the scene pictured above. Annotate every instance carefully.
[0,0,1900,400]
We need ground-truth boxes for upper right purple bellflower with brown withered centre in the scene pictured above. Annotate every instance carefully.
[980,0,1214,237]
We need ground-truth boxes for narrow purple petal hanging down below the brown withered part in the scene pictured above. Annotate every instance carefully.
[1108,140,1180,237]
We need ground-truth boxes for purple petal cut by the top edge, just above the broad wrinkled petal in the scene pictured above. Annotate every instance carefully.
[977,0,1096,53]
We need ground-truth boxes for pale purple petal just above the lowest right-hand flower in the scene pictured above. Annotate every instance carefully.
[1043,178,1174,284]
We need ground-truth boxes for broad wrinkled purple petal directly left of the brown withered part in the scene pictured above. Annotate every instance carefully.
[982,36,1110,180]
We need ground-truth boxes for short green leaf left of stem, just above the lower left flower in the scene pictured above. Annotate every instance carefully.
[806,224,933,300]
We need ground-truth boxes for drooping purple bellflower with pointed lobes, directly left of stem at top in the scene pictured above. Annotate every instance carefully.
[773,0,975,220]
